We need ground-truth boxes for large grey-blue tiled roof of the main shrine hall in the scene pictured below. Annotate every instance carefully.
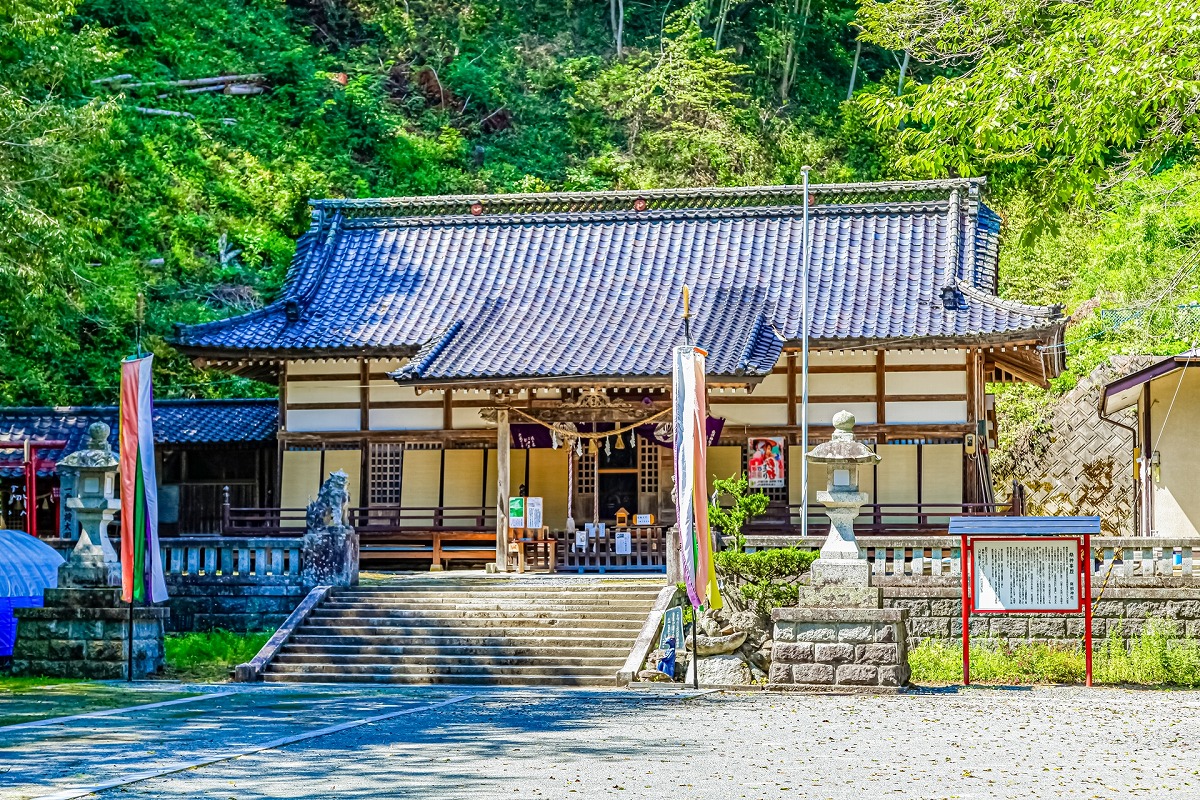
[179,181,1062,383]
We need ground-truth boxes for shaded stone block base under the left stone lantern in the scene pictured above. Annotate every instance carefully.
[12,589,170,680]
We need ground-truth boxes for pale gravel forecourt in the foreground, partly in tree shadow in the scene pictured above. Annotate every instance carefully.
[0,687,1200,800]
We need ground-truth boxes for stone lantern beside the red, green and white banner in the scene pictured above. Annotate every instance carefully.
[59,422,121,589]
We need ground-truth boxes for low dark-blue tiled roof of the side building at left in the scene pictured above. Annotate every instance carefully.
[0,399,278,477]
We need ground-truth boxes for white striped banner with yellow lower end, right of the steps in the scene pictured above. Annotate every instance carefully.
[672,345,722,608]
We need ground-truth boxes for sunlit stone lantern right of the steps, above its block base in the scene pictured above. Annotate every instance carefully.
[805,411,880,606]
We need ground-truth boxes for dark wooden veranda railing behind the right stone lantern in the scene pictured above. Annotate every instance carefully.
[745,503,1020,536]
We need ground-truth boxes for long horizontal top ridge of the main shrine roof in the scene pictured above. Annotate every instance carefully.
[310,178,986,217]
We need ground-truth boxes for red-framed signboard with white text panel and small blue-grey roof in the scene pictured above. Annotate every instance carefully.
[950,517,1100,686]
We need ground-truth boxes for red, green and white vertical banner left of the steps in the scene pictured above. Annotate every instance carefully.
[119,355,167,603]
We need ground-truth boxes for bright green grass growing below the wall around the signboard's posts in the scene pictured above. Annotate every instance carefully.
[908,619,1200,687]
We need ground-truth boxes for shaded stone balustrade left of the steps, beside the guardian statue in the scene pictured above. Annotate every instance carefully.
[161,536,302,582]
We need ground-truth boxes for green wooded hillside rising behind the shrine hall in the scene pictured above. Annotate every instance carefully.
[0,0,1200,404]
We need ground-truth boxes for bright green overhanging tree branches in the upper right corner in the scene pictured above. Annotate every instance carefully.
[858,0,1200,215]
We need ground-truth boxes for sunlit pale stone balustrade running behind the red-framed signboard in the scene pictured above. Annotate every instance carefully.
[746,530,1200,585]
